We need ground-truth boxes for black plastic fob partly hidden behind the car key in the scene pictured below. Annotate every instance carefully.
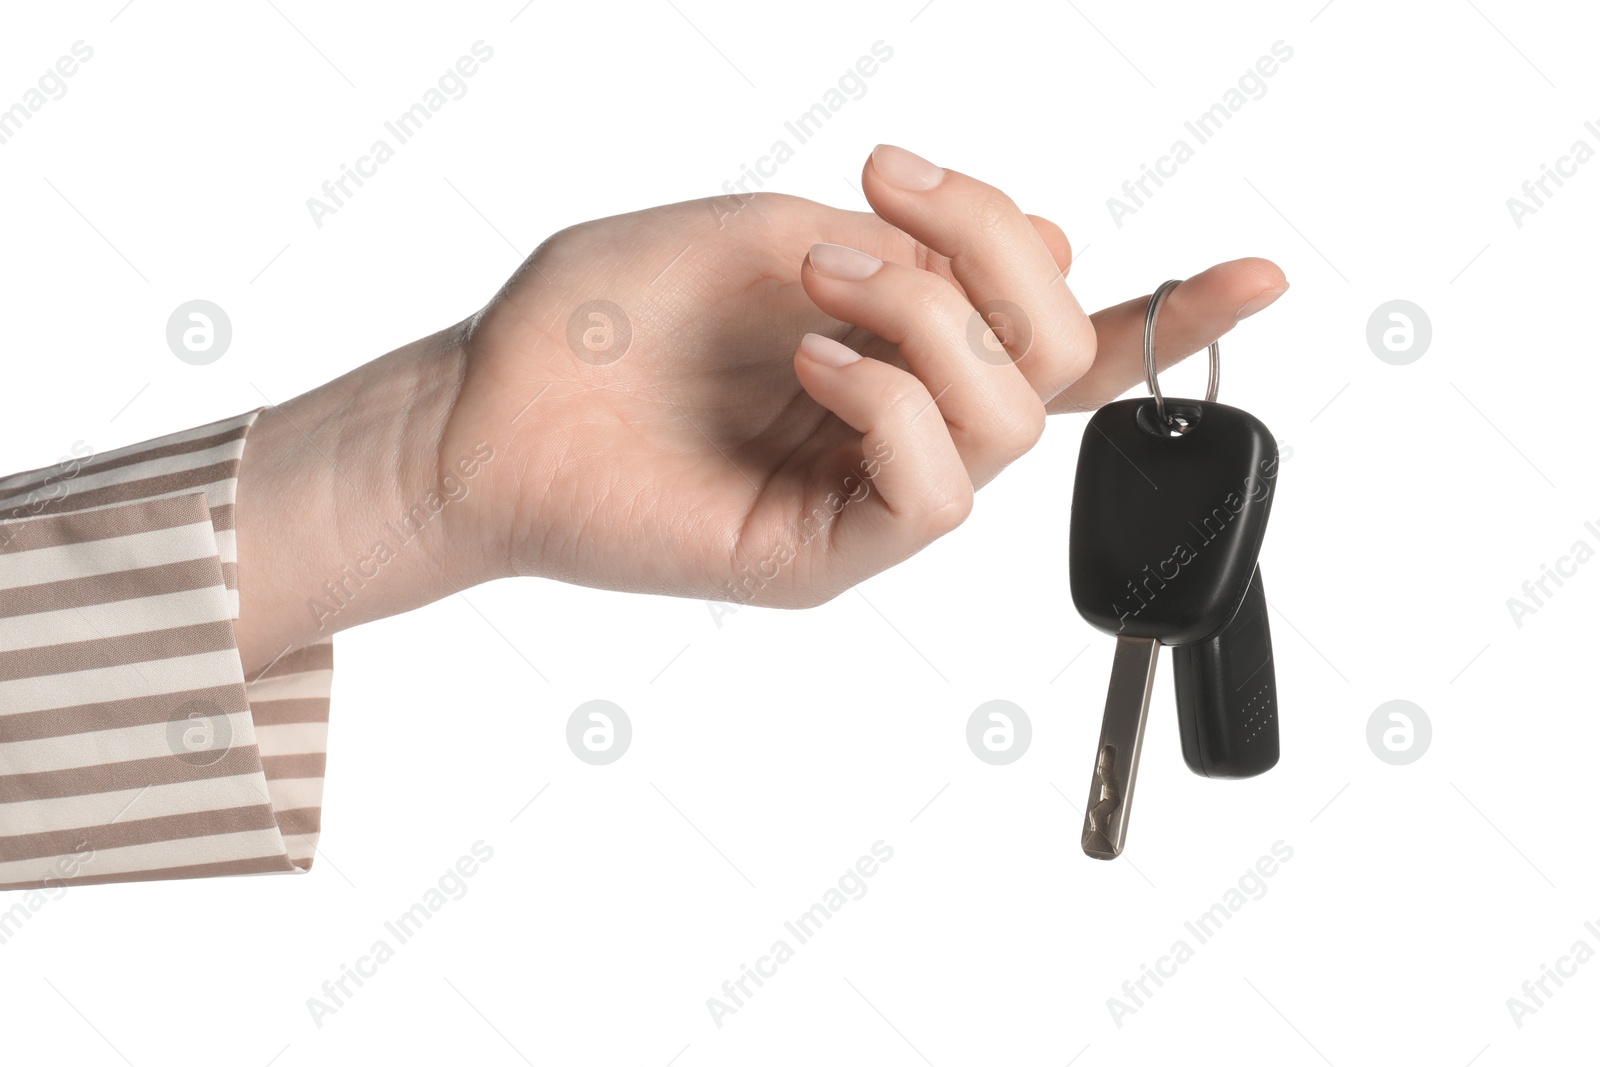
[1173,565,1278,777]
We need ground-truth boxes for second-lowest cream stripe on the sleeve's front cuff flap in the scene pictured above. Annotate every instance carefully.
[0,771,273,837]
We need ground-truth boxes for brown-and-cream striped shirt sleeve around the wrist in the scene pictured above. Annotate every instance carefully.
[0,408,333,889]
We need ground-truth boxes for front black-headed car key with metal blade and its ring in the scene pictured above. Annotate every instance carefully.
[1069,282,1277,859]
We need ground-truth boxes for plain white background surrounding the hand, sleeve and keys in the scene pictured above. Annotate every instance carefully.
[0,0,1600,1067]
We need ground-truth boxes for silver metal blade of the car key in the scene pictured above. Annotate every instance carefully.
[1083,637,1162,859]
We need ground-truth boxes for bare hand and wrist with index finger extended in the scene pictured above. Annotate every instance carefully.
[238,146,1286,669]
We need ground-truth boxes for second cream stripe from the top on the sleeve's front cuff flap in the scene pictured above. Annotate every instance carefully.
[0,584,234,655]
